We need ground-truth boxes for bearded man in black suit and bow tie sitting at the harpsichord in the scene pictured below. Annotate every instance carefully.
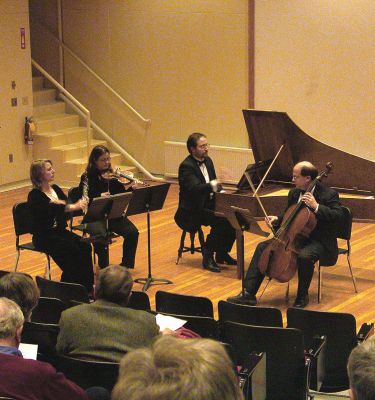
[175,133,237,272]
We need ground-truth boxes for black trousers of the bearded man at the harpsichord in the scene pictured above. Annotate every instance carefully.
[200,209,236,253]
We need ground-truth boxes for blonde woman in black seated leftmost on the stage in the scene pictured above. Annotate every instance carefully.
[27,160,94,293]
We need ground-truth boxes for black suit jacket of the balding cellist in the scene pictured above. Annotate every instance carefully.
[279,182,343,261]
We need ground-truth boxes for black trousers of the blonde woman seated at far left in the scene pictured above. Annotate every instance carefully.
[33,229,94,293]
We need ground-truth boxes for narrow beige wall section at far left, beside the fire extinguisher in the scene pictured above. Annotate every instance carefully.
[0,0,33,185]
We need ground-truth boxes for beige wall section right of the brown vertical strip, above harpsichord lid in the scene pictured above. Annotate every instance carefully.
[255,0,375,160]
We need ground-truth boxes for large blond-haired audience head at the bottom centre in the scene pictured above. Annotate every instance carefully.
[112,336,243,400]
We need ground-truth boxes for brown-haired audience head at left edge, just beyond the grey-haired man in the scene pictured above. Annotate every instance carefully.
[0,272,39,321]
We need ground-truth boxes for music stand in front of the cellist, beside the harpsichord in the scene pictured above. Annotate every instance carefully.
[225,206,269,295]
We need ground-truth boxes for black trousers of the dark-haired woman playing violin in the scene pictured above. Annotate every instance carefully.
[86,217,139,268]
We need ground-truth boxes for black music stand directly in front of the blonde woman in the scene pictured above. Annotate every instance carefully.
[82,193,132,243]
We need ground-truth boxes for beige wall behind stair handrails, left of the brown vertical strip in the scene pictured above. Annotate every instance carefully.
[63,0,248,173]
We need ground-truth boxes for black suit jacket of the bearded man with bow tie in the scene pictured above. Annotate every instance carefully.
[175,155,216,231]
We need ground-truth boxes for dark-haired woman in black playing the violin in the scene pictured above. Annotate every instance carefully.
[79,145,138,268]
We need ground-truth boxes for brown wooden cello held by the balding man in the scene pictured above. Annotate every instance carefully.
[258,162,333,282]
